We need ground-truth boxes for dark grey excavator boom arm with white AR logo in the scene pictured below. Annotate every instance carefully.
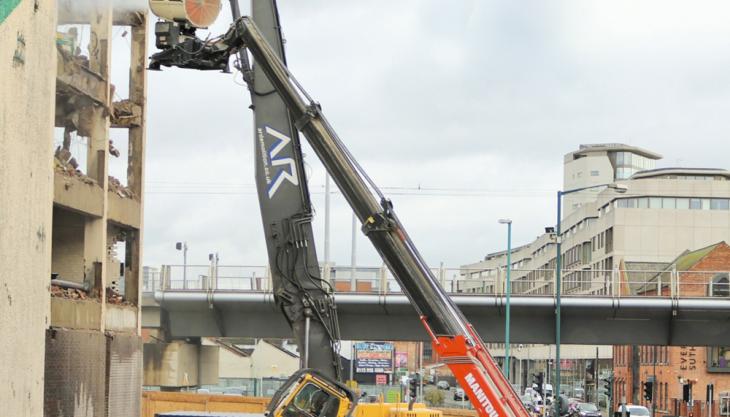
[245,0,341,380]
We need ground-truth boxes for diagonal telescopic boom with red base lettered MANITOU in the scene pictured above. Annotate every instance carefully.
[151,12,528,417]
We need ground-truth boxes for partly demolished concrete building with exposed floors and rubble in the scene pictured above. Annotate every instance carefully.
[0,0,148,417]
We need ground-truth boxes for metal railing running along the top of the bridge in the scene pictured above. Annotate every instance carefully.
[144,264,730,298]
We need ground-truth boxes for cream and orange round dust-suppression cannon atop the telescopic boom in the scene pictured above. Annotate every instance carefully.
[150,0,221,28]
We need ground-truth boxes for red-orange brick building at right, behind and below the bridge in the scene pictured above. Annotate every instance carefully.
[613,242,730,417]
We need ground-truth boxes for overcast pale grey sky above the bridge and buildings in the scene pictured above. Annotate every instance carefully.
[129,0,730,267]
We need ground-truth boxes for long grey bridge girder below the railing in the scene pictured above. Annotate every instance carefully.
[143,291,730,346]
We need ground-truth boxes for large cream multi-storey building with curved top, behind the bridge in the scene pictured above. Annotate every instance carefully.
[458,144,730,294]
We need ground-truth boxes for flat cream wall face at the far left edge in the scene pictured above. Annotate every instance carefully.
[0,0,56,417]
